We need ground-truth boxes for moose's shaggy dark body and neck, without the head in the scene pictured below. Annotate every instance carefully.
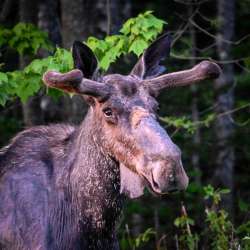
[0,114,122,250]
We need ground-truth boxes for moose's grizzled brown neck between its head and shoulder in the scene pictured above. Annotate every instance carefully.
[66,110,122,234]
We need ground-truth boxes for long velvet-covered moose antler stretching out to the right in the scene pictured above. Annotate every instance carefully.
[143,61,221,91]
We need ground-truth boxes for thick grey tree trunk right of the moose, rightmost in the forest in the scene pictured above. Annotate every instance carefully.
[215,0,235,215]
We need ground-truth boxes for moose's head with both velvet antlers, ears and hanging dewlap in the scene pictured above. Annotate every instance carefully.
[43,34,220,198]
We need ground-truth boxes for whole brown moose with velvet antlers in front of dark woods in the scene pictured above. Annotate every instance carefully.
[0,34,220,250]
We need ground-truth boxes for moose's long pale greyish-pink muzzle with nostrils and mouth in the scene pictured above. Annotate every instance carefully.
[133,110,188,194]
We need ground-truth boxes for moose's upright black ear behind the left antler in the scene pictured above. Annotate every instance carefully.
[72,41,98,79]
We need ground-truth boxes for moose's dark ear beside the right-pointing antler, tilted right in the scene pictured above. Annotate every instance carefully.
[130,33,171,79]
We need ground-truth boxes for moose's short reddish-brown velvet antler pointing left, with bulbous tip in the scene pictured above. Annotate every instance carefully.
[43,69,110,100]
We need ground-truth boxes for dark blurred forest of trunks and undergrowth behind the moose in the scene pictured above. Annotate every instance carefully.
[0,0,250,250]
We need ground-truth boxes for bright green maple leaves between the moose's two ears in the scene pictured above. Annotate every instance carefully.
[87,11,166,70]
